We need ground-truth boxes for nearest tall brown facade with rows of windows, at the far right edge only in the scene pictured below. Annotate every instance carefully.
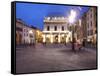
[86,7,97,44]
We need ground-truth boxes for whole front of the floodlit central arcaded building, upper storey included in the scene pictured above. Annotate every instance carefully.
[43,17,71,43]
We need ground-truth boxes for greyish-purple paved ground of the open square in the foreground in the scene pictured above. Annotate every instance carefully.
[16,44,97,73]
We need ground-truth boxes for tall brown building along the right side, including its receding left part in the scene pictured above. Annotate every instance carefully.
[81,7,97,44]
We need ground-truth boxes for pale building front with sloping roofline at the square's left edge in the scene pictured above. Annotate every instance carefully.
[16,19,36,45]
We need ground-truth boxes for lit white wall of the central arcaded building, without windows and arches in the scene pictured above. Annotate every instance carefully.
[43,18,71,43]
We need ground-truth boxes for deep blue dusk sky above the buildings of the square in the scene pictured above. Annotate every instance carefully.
[16,3,89,30]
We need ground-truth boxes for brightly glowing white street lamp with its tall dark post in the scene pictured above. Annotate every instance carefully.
[69,9,77,51]
